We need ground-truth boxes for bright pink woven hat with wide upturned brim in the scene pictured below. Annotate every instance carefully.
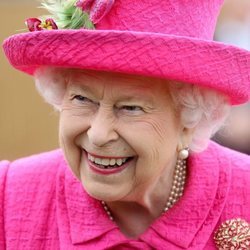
[4,0,250,104]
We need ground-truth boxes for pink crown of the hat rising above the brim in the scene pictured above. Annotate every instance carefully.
[96,0,223,40]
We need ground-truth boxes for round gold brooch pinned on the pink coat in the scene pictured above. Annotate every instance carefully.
[214,218,250,250]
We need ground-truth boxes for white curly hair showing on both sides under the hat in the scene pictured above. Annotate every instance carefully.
[35,67,231,152]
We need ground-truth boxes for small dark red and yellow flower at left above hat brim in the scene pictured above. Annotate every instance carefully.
[25,18,58,31]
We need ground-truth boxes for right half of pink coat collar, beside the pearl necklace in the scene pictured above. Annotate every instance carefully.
[143,143,231,249]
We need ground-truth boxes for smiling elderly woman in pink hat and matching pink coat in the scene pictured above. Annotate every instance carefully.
[0,0,250,250]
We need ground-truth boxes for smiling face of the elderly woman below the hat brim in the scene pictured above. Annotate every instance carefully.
[60,72,187,201]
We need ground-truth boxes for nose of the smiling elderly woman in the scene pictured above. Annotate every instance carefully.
[87,108,119,147]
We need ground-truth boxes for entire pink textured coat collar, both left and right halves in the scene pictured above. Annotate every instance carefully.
[55,143,231,249]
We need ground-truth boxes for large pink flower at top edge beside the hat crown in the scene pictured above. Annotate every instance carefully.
[76,0,115,24]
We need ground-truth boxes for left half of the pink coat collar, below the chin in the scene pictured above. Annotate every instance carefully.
[57,161,124,244]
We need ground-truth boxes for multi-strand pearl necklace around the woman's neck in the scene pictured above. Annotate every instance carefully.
[101,159,186,221]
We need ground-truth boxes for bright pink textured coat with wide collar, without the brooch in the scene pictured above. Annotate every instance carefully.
[0,143,250,250]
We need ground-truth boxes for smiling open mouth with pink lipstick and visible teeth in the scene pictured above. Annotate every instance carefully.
[87,153,134,169]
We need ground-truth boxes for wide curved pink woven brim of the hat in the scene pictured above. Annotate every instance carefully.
[4,29,250,105]
